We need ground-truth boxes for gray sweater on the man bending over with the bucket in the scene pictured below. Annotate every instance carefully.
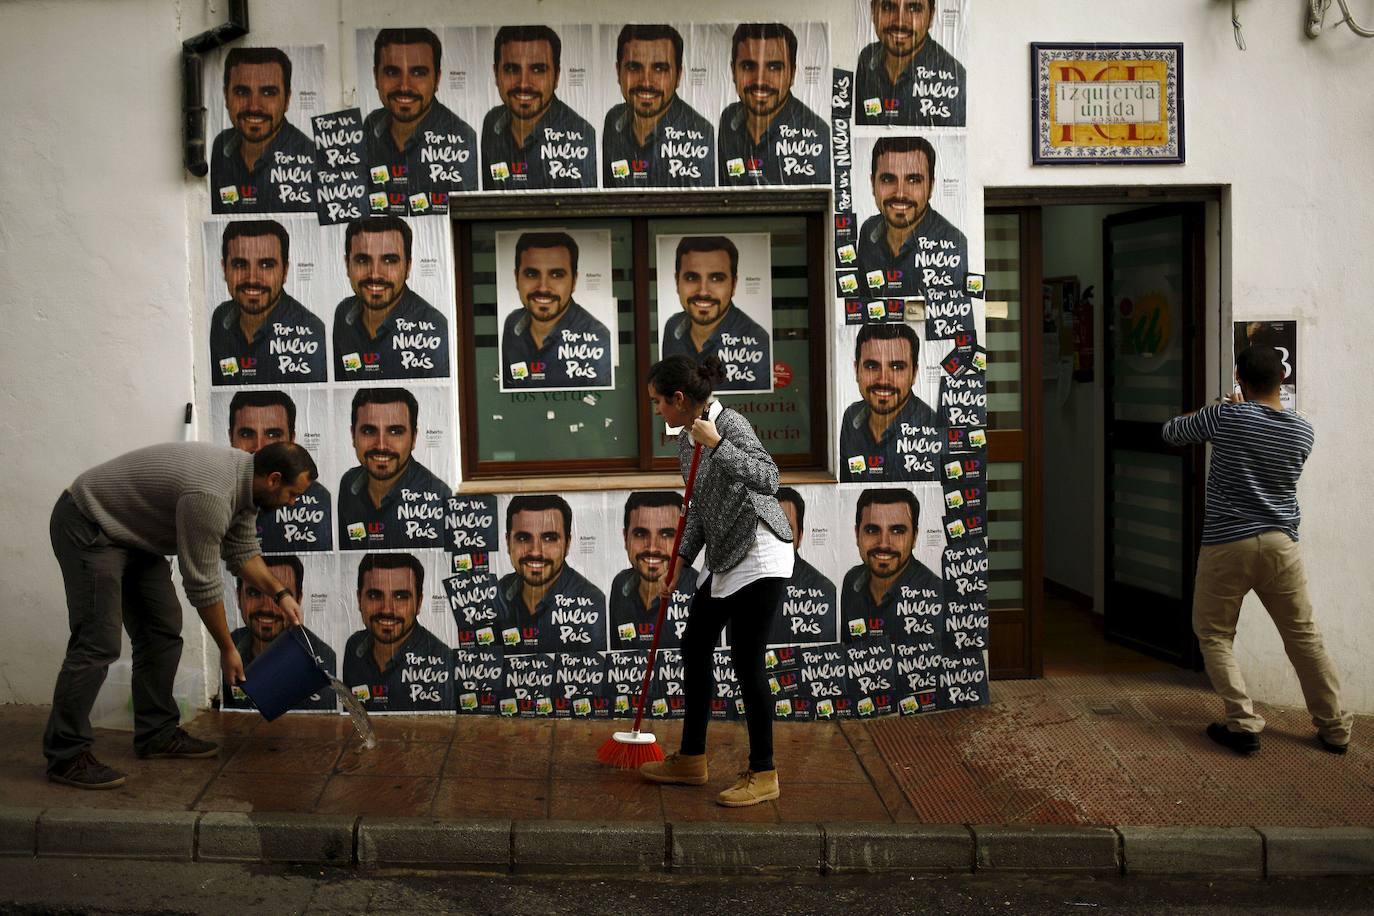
[67,442,261,608]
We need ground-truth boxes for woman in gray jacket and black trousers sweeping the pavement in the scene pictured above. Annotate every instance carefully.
[639,356,793,808]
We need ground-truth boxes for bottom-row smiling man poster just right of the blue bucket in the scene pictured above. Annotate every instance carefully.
[335,551,455,713]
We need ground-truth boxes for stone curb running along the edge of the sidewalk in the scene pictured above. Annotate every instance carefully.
[0,806,1374,878]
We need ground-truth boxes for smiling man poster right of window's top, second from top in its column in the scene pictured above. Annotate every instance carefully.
[845,130,970,299]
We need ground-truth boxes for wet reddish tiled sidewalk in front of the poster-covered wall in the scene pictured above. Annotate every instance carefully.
[0,672,1374,827]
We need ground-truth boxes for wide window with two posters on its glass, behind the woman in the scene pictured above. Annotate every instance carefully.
[455,194,830,479]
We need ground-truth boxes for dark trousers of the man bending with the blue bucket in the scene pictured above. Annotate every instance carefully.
[43,492,181,766]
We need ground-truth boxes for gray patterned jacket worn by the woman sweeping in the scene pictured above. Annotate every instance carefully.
[677,408,791,573]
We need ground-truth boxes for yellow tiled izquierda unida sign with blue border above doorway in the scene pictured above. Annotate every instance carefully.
[1031,41,1184,165]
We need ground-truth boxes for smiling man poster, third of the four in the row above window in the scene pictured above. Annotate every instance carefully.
[598,23,720,191]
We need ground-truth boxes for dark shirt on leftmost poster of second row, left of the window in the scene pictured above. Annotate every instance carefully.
[210,293,328,385]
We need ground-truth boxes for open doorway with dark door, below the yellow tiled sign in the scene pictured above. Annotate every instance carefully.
[987,188,1221,677]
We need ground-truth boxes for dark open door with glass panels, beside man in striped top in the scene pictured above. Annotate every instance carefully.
[1102,205,1205,667]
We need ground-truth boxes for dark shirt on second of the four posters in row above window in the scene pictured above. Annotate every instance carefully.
[482,98,596,191]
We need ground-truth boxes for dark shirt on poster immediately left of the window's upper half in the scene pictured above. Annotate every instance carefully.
[334,287,448,382]
